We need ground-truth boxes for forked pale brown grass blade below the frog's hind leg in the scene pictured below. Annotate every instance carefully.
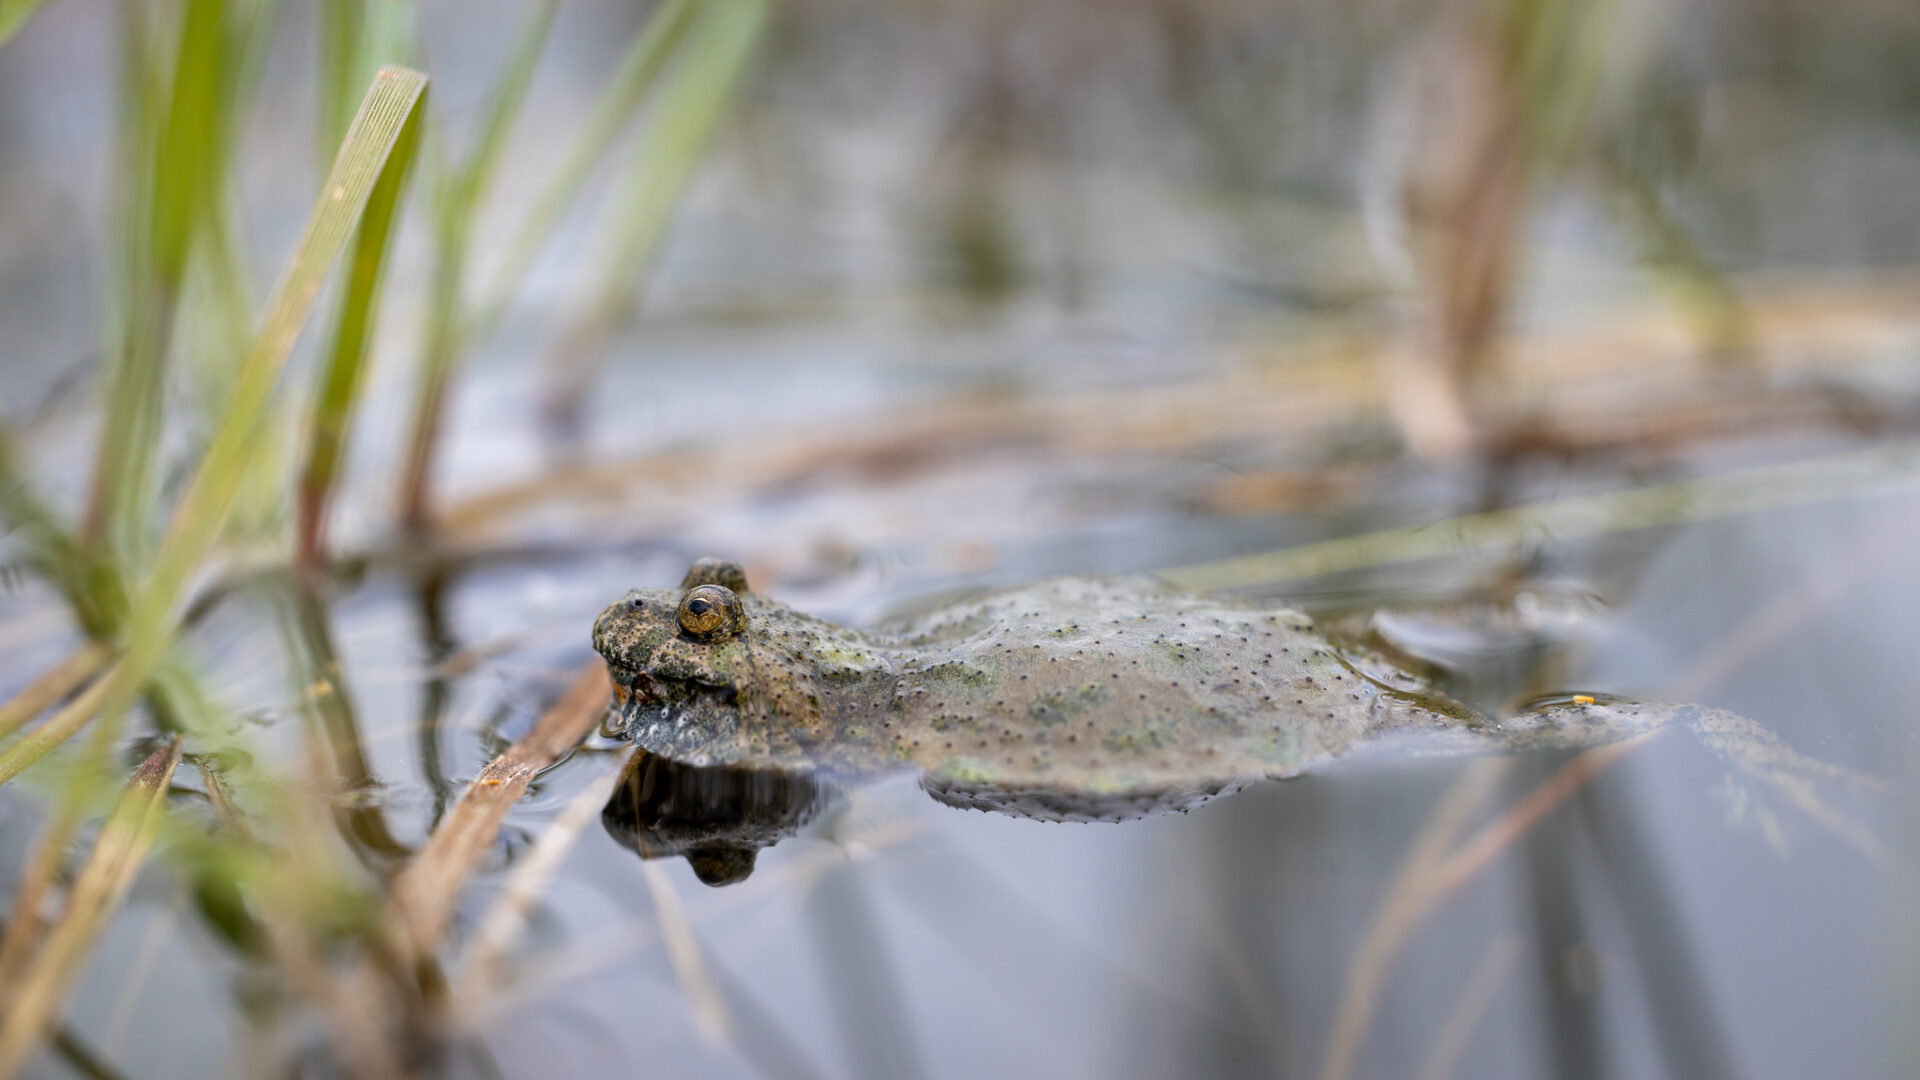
[1321,732,1659,1080]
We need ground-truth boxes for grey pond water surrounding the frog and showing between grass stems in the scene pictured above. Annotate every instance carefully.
[0,2,1920,1080]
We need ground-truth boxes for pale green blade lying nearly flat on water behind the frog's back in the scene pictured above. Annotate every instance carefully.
[1160,442,1920,592]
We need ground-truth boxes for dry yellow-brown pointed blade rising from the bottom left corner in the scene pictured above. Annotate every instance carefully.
[0,736,180,1076]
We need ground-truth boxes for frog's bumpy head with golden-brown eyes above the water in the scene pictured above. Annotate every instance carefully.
[593,559,755,732]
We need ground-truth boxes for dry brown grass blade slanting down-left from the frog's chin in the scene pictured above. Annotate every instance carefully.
[390,659,612,957]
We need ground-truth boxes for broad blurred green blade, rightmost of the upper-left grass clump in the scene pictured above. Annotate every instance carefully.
[549,0,768,417]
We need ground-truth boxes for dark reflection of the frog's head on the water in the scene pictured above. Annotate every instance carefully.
[601,749,828,886]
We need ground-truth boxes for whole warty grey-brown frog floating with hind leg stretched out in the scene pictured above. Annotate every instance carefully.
[593,557,1870,824]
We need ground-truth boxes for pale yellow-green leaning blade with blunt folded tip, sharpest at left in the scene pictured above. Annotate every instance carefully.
[94,67,426,760]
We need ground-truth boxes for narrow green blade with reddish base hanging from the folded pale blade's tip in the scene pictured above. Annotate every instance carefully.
[294,62,420,573]
